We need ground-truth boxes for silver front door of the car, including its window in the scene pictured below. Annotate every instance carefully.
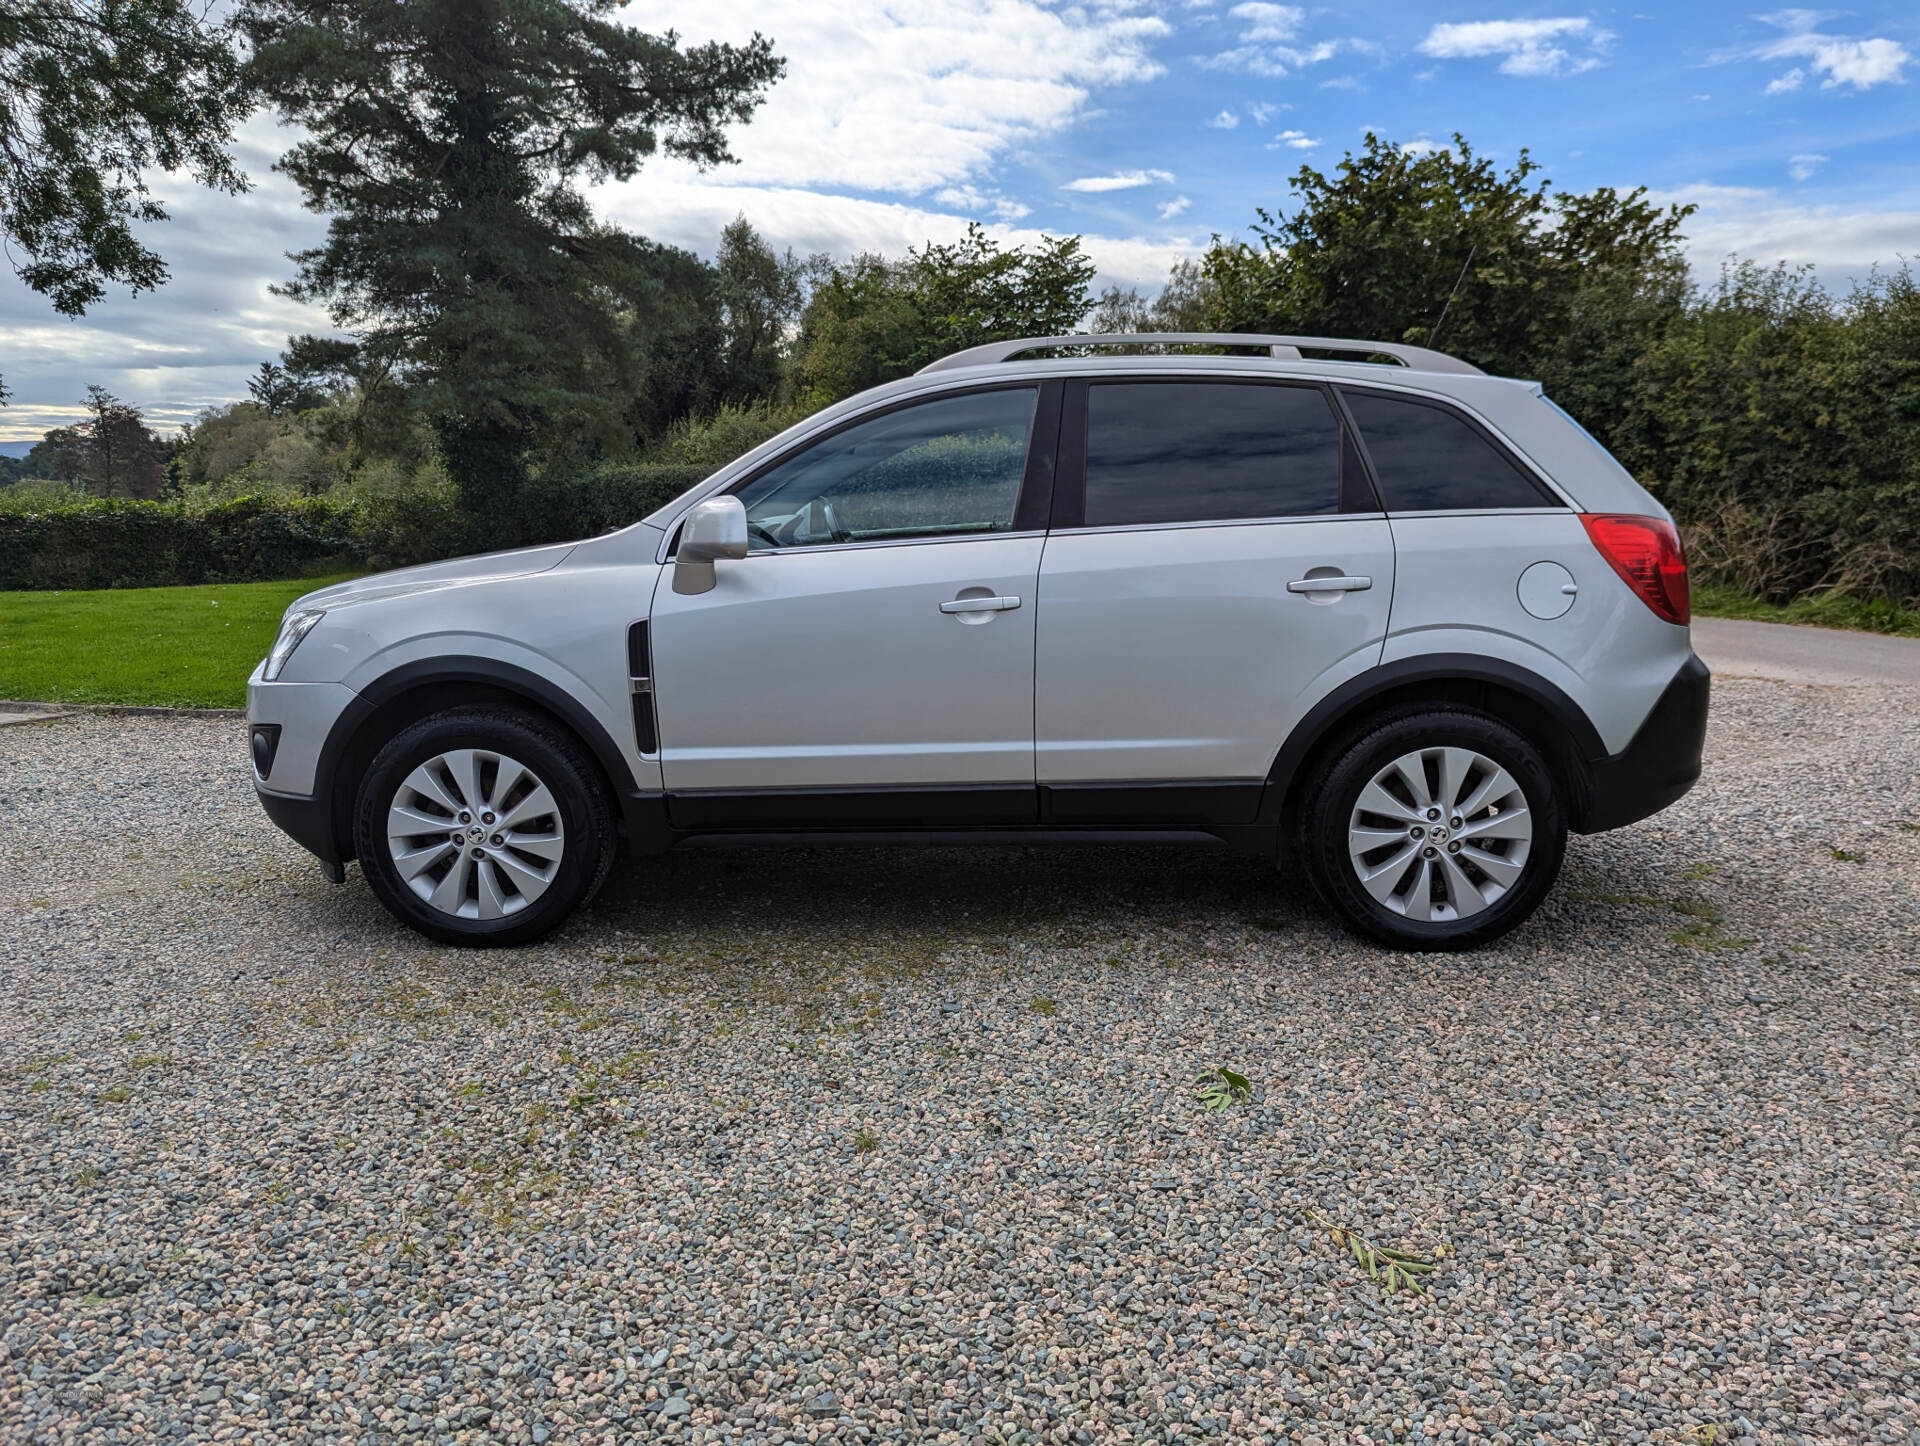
[651,386,1058,828]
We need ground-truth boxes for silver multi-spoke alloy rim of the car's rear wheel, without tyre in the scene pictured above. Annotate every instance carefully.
[1348,747,1534,924]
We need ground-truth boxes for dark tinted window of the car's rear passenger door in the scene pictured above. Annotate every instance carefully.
[1087,382,1340,528]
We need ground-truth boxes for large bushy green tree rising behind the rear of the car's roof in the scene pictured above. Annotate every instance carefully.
[1202,133,1692,374]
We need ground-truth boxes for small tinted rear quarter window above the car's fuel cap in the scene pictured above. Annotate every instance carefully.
[1342,392,1555,513]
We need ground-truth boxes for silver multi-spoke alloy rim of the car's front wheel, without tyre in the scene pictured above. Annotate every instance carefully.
[386,749,566,920]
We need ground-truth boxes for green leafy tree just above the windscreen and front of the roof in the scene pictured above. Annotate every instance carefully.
[799,225,1092,403]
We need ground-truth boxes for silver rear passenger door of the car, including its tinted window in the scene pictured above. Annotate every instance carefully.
[1035,378,1394,822]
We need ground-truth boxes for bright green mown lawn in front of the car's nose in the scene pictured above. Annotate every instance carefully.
[0,572,355,709]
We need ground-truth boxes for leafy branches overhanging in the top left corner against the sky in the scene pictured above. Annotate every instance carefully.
[0,0,248,401]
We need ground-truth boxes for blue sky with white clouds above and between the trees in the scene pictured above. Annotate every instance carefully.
[0,0,1920,439]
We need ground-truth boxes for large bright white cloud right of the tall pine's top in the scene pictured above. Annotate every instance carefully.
[620,0,1171,196]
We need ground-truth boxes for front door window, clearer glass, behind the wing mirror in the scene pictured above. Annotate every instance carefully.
[737,386,1039,547]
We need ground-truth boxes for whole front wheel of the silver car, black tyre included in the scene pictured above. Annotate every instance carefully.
[353,707,616,949]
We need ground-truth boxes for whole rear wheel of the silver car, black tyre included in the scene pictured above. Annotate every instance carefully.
[1298,707,1567,951]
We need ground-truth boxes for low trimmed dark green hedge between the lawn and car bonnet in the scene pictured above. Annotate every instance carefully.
[0,467,707,591]
